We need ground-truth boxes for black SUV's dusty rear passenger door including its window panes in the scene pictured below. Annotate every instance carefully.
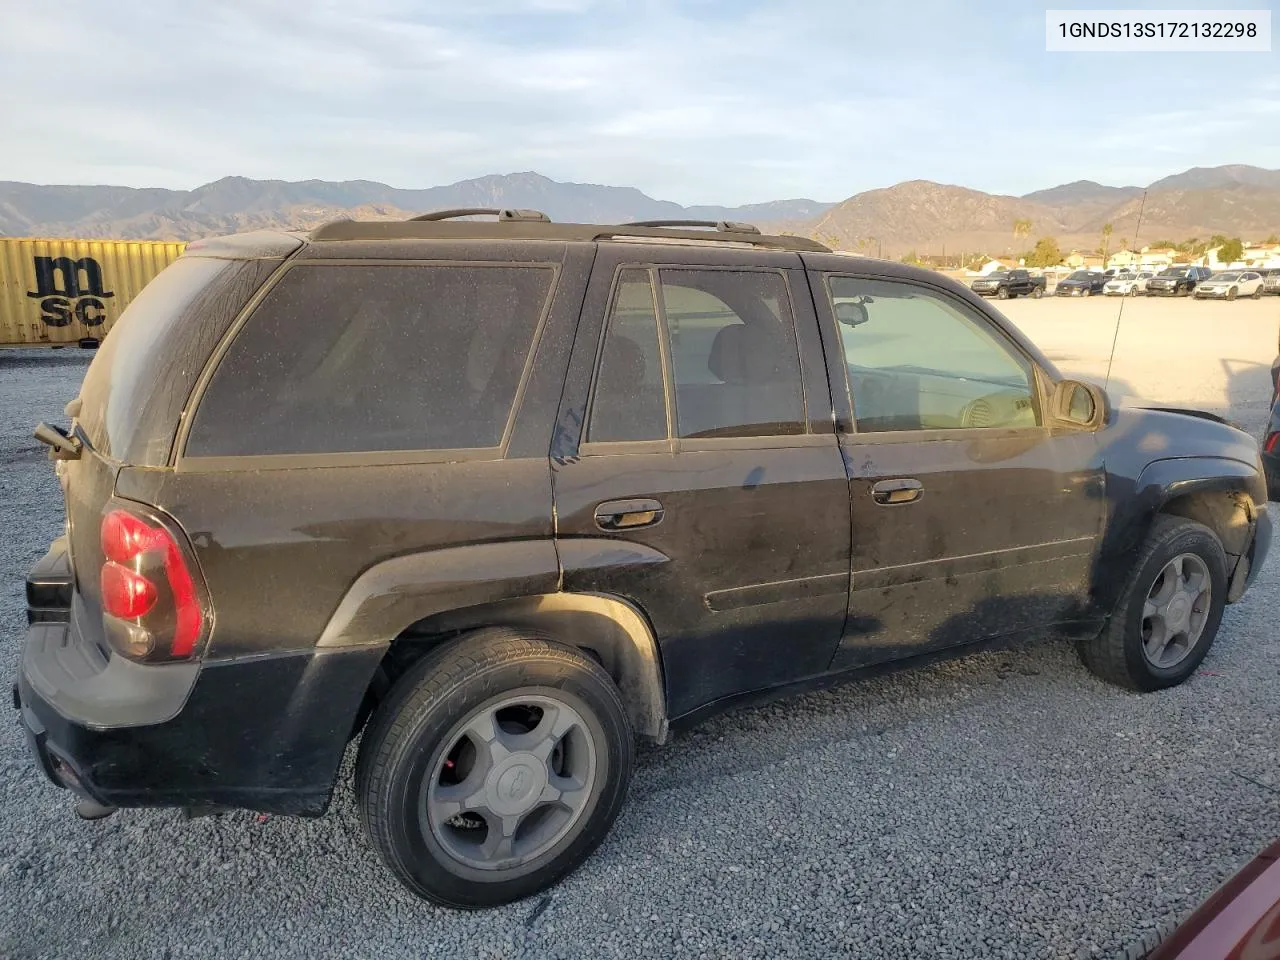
[553,242,849,717]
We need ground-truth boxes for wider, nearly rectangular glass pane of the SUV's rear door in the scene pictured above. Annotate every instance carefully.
[659,268,805,438]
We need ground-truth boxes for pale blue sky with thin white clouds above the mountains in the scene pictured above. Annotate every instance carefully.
[0,0,1280,205]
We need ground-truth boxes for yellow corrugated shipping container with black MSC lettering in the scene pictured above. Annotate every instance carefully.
[0,237,184,347]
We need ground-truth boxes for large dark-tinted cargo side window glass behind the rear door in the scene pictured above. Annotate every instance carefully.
[186,264,554,457]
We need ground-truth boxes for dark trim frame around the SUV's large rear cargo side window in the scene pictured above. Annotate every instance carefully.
[170,257,561,471]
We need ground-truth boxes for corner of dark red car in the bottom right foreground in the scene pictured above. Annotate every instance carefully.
[1147,841,1280,960]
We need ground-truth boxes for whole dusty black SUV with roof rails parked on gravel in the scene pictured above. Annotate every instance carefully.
[15,210,1271,908]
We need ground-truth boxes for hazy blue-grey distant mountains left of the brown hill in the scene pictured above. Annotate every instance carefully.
[0,173,831,239]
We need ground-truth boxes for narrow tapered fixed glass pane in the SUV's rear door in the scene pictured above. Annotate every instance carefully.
[586,270,667,443]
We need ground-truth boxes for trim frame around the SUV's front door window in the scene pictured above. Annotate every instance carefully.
[822,270,1050,443]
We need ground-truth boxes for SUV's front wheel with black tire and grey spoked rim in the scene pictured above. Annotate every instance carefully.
[1079,515,1226,691]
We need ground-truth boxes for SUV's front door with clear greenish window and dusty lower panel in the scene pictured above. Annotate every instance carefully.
[813,268,1105,667]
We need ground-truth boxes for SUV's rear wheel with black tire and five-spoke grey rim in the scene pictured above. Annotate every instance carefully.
[356,628,634,909]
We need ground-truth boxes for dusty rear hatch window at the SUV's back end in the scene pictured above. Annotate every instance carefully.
[77,256,280,466]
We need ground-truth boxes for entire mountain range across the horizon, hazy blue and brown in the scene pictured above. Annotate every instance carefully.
[0,164,1280,256]
